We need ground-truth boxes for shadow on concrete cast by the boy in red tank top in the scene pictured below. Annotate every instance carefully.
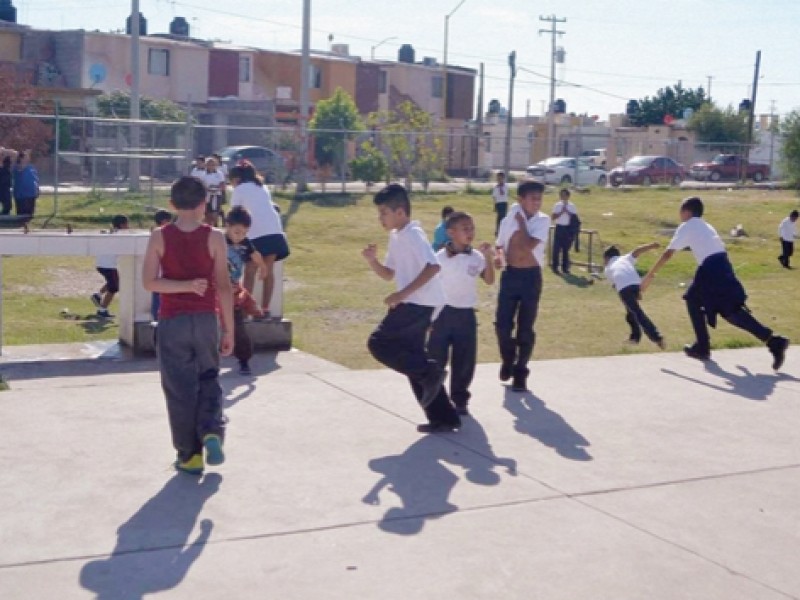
[80,473,222,600]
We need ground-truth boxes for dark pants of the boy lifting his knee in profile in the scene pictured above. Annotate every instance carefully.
[367,304,459,424]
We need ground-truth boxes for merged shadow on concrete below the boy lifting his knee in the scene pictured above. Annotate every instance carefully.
[362,417,517,535]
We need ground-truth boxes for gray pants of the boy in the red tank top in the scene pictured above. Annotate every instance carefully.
[158,313,225,461]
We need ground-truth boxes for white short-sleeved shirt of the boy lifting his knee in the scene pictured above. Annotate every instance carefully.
[383,221,445,306]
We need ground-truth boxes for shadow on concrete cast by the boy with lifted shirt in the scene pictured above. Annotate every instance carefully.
[503,386,592,461]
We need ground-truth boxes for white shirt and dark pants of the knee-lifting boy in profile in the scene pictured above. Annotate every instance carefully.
[367,221,460,425]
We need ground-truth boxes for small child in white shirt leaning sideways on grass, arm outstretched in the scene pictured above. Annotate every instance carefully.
[603,242,667,350]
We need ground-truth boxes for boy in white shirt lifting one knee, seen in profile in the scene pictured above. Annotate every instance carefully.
[361,183,461,433]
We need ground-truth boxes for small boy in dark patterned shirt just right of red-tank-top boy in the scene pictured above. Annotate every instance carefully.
[225,206,267,375]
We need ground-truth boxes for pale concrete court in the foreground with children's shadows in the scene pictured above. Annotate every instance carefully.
[0,347,800,600]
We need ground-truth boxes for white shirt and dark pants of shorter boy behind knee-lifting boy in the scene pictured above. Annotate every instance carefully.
[428,245,486,408]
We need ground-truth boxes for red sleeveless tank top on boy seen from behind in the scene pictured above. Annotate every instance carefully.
[158,223,217,319]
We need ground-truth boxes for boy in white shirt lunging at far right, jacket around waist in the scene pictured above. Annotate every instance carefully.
[641,196,789,371]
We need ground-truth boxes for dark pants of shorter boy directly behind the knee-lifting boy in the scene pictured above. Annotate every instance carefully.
[428,306,478,406]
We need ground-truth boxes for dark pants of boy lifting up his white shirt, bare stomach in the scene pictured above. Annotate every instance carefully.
[494,267,542,378]
